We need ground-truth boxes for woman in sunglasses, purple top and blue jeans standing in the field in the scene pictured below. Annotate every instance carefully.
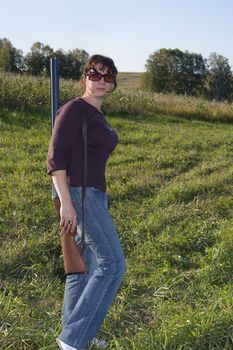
[48,55,125,350]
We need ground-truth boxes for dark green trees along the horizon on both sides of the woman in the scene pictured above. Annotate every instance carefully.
[0,38,233,101]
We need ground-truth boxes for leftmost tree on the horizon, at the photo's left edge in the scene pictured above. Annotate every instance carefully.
[0,38,25,73]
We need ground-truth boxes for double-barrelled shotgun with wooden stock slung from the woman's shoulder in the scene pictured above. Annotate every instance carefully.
[50,58,87,275]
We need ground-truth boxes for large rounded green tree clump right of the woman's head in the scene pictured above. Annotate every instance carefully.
[143,48,206,95]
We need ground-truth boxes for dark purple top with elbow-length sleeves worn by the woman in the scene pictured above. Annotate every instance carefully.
[47,98,118,192]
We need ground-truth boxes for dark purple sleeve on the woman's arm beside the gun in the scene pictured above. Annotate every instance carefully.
[47,100,81,175]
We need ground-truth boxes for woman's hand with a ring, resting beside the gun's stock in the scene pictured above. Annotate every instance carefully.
[60,204,77,235]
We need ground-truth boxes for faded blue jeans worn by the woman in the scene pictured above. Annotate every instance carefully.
[58,187,125,349]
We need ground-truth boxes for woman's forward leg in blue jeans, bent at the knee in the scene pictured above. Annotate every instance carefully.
[59,188,125,349]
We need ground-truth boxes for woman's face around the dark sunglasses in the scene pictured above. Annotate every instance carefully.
[85,63,114,98]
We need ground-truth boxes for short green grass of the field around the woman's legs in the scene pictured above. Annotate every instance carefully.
[0,109,233,350]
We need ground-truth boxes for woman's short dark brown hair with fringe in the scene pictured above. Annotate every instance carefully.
[81,55,118,91]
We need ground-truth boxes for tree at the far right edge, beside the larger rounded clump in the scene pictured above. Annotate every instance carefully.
[207,52,233,100]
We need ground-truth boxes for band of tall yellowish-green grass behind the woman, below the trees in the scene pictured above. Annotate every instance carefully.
[0,73,233,122]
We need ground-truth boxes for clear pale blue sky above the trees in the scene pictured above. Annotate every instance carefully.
[0,0,233,72]
